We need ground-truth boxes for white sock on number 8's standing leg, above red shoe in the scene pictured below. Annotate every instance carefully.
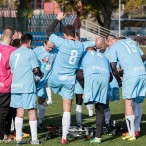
[62,112,71,140]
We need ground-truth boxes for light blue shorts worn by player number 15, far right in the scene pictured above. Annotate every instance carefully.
[122,75,146,101]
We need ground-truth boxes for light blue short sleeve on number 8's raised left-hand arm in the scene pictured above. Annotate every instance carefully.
[49,34,65,49]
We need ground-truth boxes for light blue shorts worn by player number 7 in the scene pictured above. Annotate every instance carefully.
[10,93,37,109]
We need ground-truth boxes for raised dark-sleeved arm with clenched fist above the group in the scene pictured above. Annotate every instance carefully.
[46,12,65,36]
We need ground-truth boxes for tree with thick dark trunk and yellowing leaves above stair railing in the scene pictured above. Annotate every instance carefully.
[56,0,142,29]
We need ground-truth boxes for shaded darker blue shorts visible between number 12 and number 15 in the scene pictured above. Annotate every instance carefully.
[107,88,120,101]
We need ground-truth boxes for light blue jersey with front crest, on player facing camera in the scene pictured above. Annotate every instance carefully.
[33,46,58,88]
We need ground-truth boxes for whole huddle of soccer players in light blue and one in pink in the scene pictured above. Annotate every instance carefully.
[0,12,146,145]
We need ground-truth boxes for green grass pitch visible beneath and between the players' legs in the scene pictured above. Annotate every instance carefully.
[0,47,146,146]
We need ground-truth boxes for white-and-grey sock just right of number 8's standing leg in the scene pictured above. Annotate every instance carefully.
[75,104,82,125]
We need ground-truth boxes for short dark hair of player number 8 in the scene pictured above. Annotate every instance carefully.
[63,25,75,37]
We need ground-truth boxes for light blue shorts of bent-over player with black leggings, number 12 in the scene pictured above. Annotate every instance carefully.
[84,74,109,104]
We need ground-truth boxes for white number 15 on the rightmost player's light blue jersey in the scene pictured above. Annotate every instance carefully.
[121,41,137,53]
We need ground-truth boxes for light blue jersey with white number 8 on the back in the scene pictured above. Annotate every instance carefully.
[48,34,84,84]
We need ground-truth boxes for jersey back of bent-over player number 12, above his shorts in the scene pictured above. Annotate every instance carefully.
[81,51,110,78]
